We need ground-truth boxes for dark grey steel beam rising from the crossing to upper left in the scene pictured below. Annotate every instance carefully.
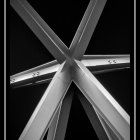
[10,0,69,63]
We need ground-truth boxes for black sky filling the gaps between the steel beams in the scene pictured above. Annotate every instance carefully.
[8,0,133,140]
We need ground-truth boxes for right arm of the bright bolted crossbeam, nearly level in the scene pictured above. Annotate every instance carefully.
[81,55,130,74]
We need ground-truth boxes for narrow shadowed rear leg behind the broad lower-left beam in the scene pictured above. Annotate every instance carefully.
[47,87,73,140]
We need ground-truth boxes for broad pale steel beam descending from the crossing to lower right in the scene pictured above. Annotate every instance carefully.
[73,60,130,140]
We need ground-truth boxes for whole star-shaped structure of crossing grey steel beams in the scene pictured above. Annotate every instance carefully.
[10,0,130,140]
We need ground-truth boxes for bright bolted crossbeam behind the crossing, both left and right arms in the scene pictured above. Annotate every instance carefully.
[10,55,130,88]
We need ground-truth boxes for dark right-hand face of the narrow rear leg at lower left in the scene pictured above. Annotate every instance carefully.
[53,89,73,140]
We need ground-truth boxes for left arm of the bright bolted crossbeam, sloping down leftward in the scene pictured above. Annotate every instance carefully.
[10,61,60,87]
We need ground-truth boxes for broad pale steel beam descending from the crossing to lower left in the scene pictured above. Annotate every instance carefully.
[19,62,71,140]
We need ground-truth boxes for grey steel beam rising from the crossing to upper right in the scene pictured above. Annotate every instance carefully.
[70,0,107,60]
